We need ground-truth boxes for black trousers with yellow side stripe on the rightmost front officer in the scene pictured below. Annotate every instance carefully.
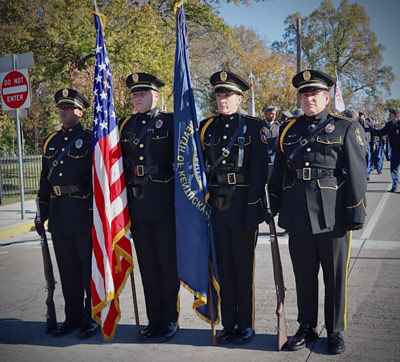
[289,230,351,333]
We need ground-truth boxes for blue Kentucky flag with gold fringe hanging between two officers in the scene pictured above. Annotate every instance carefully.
[174,1,220,323]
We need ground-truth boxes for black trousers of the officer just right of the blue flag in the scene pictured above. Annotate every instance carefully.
[214,223,258,329]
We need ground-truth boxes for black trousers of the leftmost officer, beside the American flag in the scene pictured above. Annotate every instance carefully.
[51,234,92,323]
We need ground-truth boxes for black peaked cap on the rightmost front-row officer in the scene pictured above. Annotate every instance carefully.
[292,69,335,93]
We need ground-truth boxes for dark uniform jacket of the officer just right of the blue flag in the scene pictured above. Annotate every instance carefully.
[200,113,268,229]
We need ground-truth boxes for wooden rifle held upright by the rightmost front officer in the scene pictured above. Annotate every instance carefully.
[265,186,288,351]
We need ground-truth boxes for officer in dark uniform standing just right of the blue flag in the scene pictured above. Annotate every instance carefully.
[200,71,268,344]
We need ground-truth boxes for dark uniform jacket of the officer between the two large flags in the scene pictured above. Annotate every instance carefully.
[119,108,175,223]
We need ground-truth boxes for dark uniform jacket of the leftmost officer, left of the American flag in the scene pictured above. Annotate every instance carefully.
[38,123,93,236]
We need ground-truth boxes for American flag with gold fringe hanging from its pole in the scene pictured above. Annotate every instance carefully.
[91,12,133,341]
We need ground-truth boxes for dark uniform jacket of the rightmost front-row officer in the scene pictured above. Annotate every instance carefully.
[269,110,367,234]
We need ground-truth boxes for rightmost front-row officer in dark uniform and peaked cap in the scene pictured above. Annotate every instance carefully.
[268,70,367,354]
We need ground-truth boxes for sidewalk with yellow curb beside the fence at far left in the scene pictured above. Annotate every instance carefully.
[0,200,36,240]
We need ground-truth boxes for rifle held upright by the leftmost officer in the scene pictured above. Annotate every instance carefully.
[35,198,57,334]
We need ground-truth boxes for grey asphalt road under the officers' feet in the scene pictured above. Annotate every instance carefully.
[0,163,400,362]
